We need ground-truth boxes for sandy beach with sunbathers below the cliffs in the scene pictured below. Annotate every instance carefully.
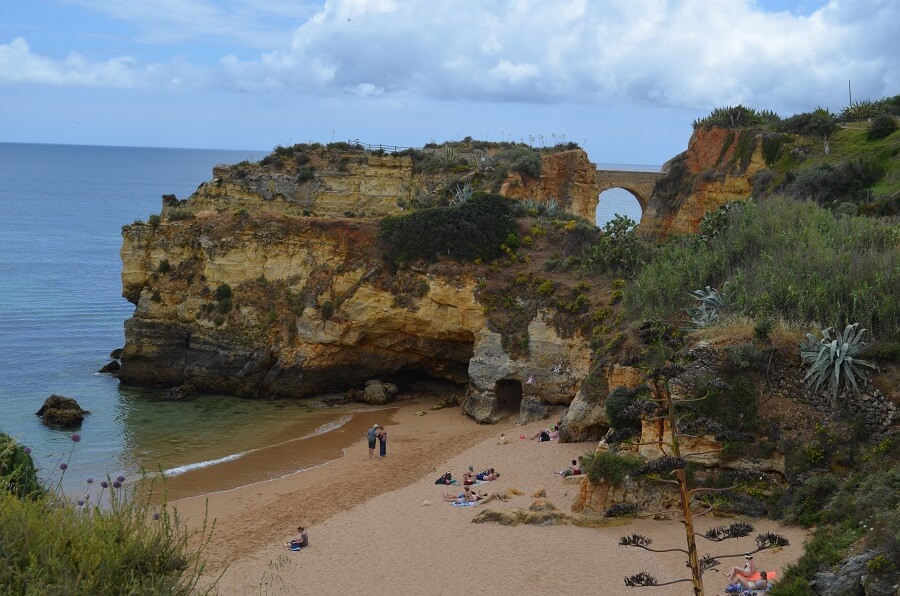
[175,400,805,595]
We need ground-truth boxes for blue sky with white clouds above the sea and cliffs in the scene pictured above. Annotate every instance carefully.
[0,0,900,165]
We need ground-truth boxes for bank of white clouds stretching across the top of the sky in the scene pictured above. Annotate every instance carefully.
[8,0,900,111]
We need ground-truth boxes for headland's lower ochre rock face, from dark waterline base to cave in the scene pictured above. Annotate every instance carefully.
[119,214,484,397]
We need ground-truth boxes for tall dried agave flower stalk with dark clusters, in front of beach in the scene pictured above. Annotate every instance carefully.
[619,366,788,596]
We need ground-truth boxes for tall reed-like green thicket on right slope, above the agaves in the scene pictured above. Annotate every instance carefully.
[625,198,900,341]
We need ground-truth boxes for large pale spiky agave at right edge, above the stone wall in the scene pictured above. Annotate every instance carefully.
[800,323,877,406]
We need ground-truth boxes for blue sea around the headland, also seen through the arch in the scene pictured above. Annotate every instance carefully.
[0,143,658,495]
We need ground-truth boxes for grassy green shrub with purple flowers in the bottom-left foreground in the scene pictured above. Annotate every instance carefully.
[0,434,215,596]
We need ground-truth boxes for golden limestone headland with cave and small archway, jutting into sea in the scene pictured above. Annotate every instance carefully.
[119,147,605,422]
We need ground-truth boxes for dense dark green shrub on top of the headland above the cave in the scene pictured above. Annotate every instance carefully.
[381,194,516,263]
